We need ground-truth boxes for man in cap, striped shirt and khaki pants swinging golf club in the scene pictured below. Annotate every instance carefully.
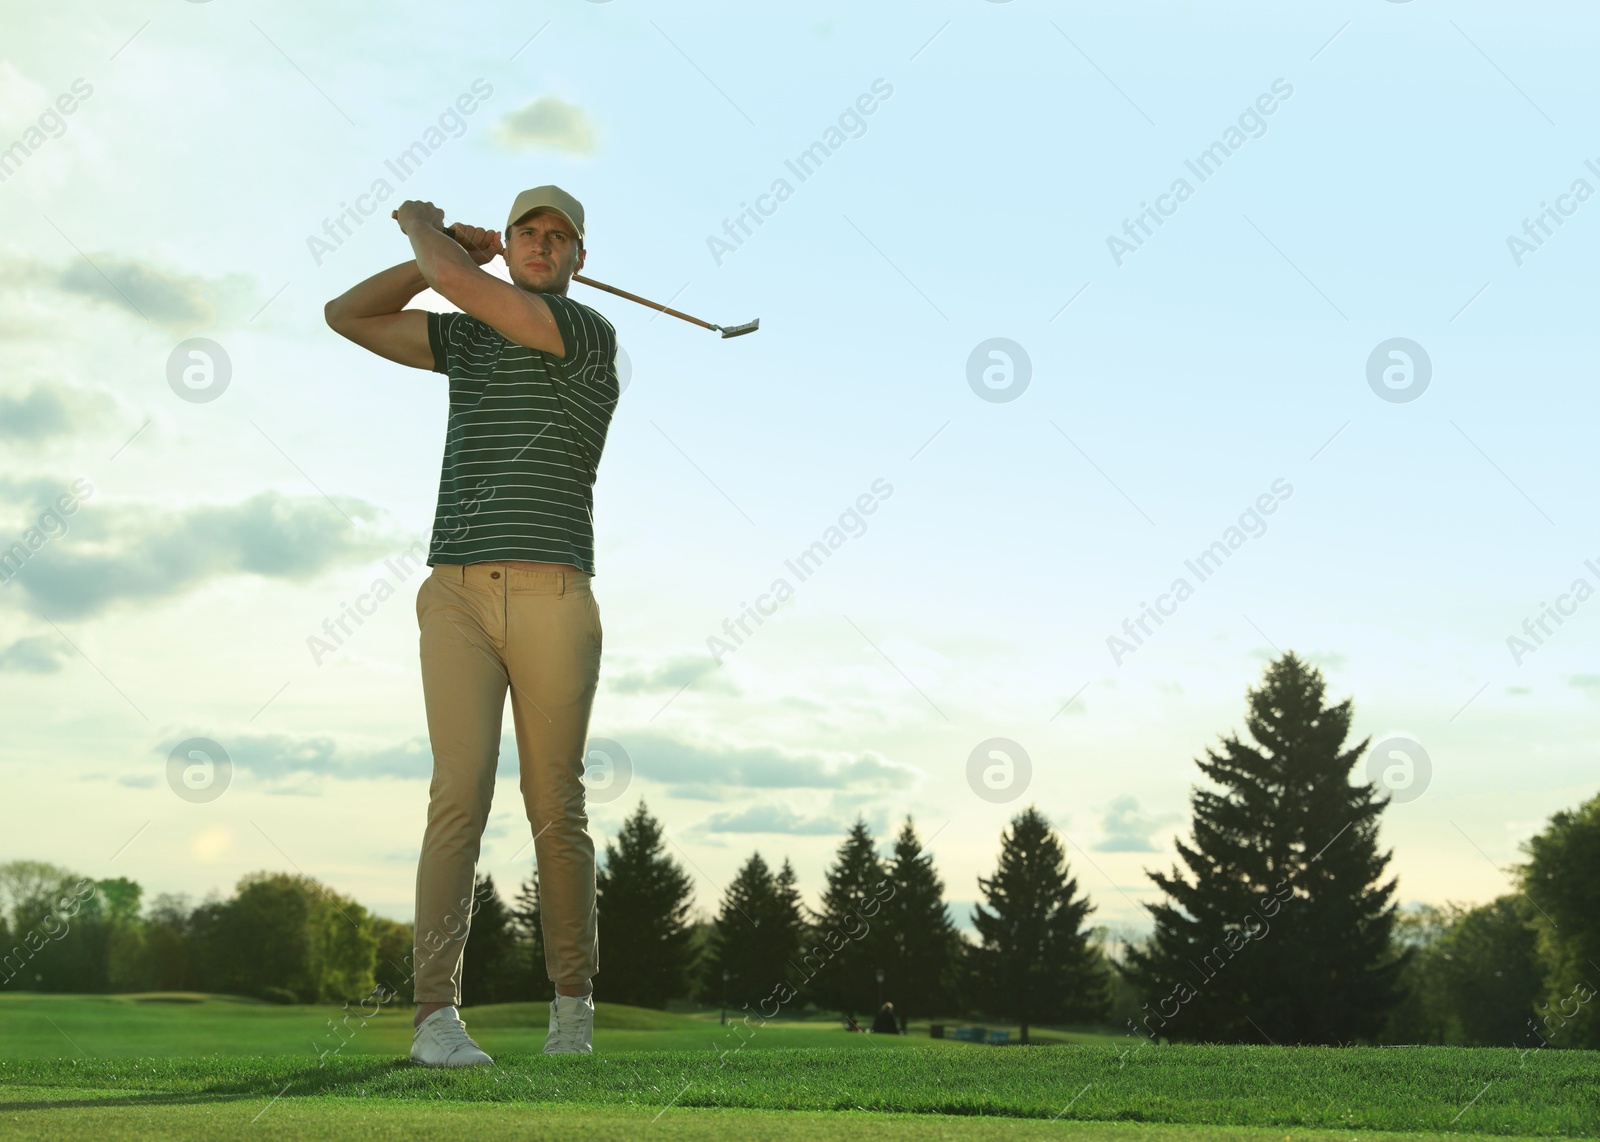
[326,186,618,1067]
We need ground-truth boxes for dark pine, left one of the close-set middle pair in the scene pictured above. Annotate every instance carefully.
[797,819,894,1017]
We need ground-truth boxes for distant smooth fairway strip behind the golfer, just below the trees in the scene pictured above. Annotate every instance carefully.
[0,992,1117,1059]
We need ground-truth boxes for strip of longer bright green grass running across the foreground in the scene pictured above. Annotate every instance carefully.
[0,1032,1600,1137]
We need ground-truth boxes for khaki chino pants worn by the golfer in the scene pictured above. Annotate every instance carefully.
[413,563,602,1003]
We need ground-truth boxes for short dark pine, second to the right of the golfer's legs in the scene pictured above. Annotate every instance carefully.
[699,853,805,1017]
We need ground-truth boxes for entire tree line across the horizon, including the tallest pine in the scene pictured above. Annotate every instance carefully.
[0,651,1600,1049]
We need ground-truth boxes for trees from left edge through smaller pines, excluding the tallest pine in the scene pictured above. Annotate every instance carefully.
[0,805,1112,1036]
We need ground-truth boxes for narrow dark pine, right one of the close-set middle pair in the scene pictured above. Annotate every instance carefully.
[883,817,962,1019]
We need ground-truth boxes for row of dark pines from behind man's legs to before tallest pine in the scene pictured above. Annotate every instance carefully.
[448,803,1112,1038]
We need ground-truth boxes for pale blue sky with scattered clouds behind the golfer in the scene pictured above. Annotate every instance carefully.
[0,0,1600,929]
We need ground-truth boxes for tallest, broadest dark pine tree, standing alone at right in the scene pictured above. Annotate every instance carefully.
[1125,651,1406,1043]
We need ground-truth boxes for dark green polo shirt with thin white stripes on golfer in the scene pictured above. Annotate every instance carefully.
[427,293,618,574]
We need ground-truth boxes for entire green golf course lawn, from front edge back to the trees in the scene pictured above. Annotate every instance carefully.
[0,996,1600,1142]
